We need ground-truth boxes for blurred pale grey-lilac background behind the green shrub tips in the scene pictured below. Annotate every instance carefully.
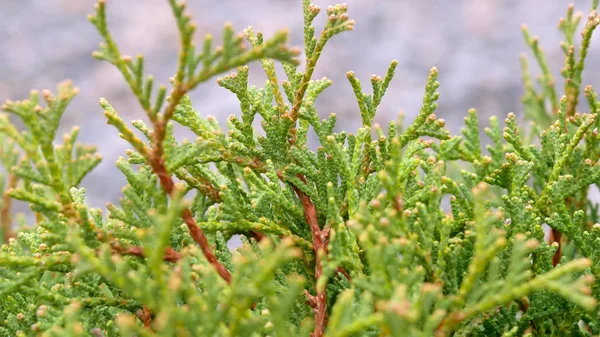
[0,0,600,207]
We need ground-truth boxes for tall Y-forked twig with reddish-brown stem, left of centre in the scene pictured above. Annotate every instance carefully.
[90,0,298,283]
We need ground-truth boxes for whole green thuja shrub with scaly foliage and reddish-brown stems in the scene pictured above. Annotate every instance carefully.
[0,0,600,337]
